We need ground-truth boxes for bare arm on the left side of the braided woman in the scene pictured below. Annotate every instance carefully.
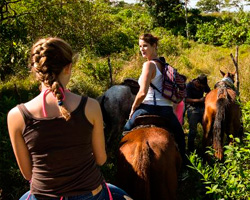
[7,107,32,180]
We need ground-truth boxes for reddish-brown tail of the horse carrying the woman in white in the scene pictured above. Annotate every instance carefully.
[133,141,153,200]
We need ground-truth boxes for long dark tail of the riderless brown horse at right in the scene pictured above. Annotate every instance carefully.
[213,88,229,159]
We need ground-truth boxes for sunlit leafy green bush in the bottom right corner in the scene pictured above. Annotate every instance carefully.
[189,102,250,200]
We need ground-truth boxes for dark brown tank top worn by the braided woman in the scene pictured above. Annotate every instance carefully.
[18,97,103,198]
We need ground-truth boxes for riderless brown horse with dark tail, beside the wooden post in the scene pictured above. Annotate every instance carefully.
[203,70,242,160]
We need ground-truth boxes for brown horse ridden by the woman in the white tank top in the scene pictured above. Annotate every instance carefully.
[117,115,181,200]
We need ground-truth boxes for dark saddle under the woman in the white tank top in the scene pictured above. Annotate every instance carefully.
[133,115,169,129]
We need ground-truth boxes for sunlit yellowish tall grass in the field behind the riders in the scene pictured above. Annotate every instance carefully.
[107,38,250,102]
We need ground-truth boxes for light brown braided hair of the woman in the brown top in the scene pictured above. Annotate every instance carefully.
[29,37,73,120]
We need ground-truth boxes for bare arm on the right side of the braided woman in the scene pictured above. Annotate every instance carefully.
[85,98,107,166]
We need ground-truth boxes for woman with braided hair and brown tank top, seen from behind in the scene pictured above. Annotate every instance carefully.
[8,38,129,200]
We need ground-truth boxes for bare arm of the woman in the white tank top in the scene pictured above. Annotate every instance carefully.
[129,61,156,118]
